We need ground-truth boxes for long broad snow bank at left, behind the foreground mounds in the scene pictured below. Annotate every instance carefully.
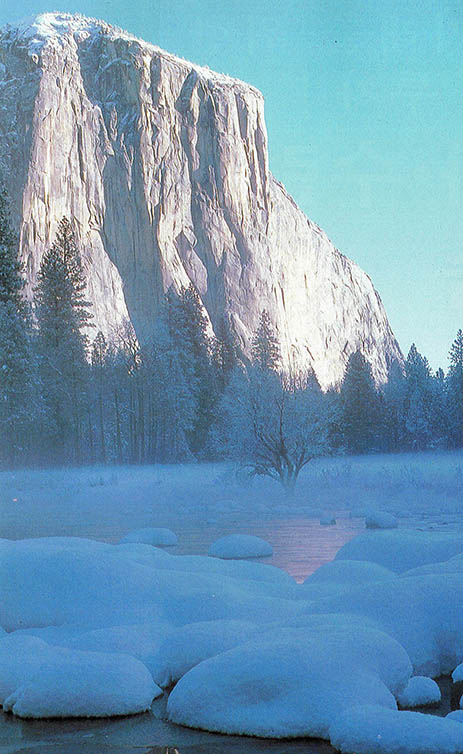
[0,538,300,631]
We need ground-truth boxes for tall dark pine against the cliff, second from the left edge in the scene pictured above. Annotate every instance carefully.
[35,218,91,462]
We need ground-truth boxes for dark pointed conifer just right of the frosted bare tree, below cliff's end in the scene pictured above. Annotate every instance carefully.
[340,351,380,453]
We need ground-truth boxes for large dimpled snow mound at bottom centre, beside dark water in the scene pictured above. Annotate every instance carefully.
[167,621,411,738]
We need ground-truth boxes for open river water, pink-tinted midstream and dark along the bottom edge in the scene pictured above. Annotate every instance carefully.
[0,508,364,754]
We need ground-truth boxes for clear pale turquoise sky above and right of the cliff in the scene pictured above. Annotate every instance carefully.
[0,0,463,368]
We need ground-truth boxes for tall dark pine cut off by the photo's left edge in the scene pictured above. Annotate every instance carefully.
[0,184,37,465]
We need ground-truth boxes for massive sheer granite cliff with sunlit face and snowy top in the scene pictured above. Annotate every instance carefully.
[0,14,402,386]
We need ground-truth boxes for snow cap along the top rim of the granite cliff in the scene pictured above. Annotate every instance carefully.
[0,11,263,97]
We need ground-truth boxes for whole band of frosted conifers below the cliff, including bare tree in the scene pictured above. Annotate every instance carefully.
[0,186,463,492]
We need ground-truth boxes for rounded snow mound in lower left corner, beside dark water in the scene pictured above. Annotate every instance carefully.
[3,651,162,718]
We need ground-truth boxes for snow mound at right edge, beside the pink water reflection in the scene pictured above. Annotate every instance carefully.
[335,529,463,573]
